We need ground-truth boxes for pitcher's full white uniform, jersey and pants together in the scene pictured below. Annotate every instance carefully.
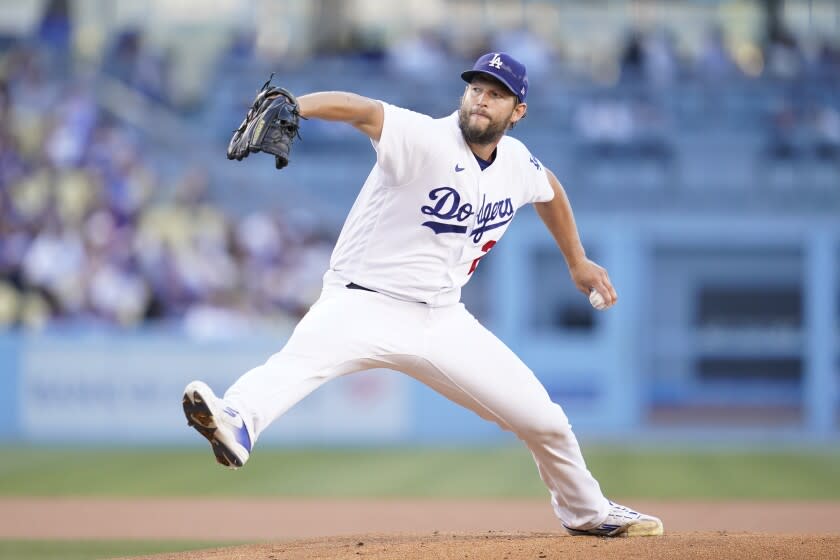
[224,100,610,528]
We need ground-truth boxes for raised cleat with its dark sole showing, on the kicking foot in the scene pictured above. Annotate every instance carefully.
[182,381,252,469]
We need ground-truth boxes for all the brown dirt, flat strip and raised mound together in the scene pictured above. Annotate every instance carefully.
[0,498,840,560]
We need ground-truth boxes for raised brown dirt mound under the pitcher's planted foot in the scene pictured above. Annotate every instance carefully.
[118,532,840,560]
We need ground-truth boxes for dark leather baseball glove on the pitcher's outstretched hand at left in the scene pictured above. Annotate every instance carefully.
[227,73,303,169]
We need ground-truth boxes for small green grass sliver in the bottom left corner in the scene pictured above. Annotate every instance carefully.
[0,540,240,560]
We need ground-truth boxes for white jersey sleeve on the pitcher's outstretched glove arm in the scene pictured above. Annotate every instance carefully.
[371,102,434,186]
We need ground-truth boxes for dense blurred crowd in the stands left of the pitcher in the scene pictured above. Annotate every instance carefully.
[0,48,330,336]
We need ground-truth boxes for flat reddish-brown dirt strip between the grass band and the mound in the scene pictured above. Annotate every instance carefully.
[0,498,840,540]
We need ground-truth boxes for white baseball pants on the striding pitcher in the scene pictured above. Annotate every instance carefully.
[224,279,609,529]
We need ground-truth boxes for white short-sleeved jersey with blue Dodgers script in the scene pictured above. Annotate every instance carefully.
[327,103,554,306]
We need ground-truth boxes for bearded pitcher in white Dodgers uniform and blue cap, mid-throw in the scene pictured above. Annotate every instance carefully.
[183,52,663,536]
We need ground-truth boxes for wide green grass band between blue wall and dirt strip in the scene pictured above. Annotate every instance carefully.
[0,447,840,500]
